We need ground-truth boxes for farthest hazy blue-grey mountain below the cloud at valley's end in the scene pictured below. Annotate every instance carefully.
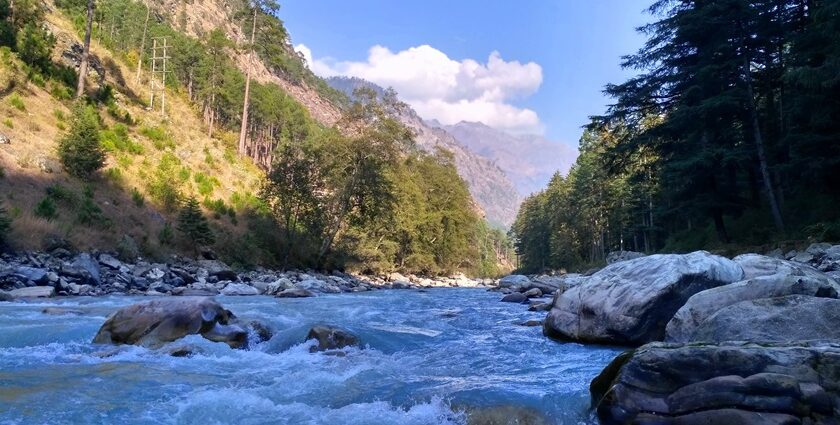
[442,121,578,194]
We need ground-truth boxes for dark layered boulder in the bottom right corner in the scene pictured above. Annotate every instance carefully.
[590,342,840,425]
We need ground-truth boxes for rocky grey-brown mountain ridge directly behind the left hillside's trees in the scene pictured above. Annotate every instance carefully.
[327,77,522,227]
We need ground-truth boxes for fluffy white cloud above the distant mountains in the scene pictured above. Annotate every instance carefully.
[295,44,543,133]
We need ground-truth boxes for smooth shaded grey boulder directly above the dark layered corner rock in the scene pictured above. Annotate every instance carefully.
[667,295,840,343]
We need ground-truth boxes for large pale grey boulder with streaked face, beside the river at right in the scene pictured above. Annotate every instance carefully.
[544,251,744,345]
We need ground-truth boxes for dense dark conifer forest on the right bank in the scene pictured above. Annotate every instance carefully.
[513,0,840,270]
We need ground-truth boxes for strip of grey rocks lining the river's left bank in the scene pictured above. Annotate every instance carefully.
[0,249,496,300]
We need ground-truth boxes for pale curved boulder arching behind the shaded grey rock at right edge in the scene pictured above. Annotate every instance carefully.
[665,273,840,342]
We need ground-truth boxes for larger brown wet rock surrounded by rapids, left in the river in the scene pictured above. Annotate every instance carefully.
[93,297,248,348]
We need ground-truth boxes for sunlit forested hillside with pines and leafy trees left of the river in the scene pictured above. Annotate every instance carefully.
[0,0,511,276]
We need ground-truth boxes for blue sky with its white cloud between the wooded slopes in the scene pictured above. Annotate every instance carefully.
[279,0,651,146]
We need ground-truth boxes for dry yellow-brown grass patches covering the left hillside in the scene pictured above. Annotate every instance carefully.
[0,7,262,254]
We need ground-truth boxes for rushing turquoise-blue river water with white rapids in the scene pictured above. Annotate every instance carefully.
[0,289,618,424]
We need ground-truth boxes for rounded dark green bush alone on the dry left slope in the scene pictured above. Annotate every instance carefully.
[58,105,105,179]
